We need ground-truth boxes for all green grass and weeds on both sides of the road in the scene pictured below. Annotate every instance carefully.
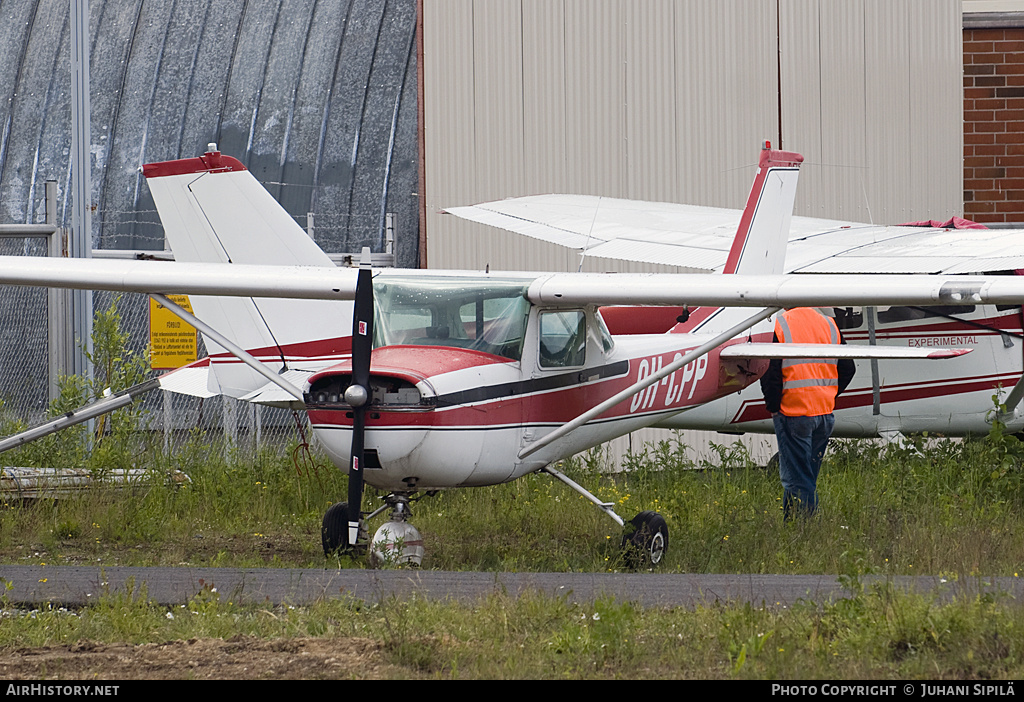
[0,298,1024,678]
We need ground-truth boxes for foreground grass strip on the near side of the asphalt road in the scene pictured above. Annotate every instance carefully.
[6,583,1024,679]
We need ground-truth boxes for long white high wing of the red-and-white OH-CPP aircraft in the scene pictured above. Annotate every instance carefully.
[0,256,1024,307]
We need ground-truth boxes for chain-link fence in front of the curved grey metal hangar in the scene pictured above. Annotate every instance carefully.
[0,160,415,456]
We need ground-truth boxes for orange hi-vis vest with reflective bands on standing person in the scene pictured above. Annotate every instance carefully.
[775,307,840,416]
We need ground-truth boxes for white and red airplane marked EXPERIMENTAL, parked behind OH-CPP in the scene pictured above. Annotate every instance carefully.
[449,187,1024,440]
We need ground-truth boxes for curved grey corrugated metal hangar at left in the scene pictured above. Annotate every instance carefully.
[0,0,419,266]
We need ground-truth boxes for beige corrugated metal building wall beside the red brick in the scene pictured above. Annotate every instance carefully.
[423,0,963,270]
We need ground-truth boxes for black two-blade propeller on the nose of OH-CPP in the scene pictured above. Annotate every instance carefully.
[345,248,374,545]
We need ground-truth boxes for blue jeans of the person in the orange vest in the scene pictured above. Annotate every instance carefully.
[773,412,836,520]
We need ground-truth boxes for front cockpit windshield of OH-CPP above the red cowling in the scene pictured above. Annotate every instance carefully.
[374,275,529,360]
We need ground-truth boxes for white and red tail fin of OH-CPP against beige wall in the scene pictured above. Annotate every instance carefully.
[673,141,804,333]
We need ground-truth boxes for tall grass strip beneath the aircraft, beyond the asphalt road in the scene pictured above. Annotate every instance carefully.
[6,425,1024,576]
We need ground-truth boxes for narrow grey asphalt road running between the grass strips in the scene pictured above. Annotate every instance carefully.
[0,565,1024,607]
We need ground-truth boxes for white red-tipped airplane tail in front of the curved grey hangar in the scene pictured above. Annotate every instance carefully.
[142,144,352,397]
